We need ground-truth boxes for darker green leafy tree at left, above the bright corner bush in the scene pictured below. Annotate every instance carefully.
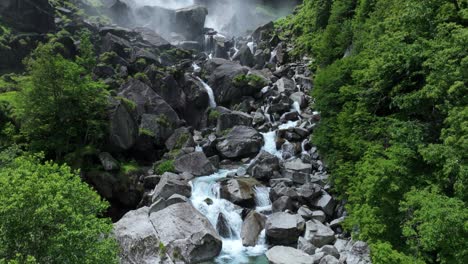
[18,44,107,159]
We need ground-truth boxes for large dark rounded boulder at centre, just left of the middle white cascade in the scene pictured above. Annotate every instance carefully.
[216,126,263,159]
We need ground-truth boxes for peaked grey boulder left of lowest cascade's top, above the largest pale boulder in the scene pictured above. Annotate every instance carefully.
[153,172,192,202]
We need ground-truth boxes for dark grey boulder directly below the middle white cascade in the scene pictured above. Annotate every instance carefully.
[247,150,280,180]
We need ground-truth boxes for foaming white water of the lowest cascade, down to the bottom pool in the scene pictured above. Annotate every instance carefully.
[190,170,268,264]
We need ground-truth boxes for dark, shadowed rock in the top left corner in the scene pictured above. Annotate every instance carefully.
[0,0,55,33]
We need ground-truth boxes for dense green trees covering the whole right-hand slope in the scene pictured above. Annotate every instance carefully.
[278,0,468,264]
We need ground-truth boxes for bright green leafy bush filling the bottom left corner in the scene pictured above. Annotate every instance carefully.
[0,154,117,263]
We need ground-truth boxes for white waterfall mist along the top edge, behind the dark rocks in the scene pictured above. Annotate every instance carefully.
[121,0,297,37]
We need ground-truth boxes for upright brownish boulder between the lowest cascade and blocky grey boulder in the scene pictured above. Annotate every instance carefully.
[241,211,266,247]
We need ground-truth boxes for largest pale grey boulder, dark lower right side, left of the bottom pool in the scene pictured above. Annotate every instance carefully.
[150,203,222,263]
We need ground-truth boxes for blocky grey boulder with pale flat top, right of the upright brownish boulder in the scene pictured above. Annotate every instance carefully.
[265,213,305,245]
